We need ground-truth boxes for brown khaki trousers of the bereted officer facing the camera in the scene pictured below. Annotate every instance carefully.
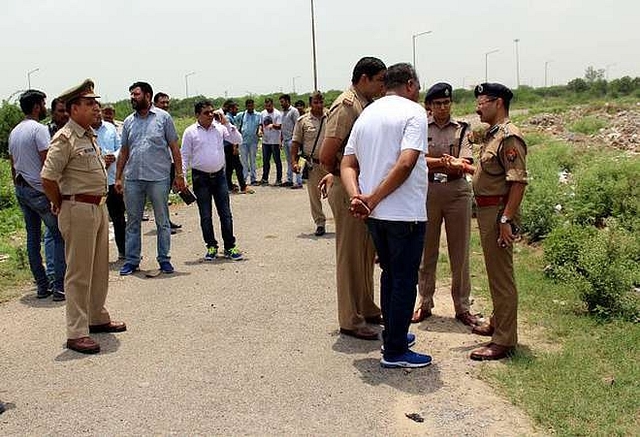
[418,178,471,314]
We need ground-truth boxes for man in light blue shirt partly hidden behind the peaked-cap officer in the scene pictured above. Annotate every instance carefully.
[91,102,126,260]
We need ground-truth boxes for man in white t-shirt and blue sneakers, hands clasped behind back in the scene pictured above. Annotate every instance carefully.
[340,63,431,367]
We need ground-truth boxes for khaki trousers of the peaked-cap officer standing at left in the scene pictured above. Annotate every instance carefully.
[58,200,111,339]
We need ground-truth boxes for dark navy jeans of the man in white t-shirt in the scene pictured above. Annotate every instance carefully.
[367,218,426,357]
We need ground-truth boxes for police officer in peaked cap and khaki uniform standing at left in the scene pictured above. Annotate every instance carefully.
[41,79,127,354]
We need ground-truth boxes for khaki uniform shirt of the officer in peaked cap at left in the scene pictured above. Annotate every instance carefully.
[40,120,107,195]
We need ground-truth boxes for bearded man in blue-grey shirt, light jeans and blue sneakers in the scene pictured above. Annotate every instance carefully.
[114,82,185,276]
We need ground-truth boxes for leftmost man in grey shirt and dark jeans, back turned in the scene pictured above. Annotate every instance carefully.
[9,90,66,301]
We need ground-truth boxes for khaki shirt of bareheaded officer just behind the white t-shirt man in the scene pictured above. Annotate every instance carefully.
[324,86,370,162]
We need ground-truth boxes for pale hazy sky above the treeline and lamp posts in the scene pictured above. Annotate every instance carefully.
[0,0,640,101]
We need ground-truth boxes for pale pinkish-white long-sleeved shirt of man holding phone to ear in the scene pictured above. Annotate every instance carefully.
[180,120,242,174]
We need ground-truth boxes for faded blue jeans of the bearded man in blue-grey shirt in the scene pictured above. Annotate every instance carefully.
[124,175,171,266]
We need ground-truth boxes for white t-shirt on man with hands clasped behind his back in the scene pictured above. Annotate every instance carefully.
[344,95,428,221]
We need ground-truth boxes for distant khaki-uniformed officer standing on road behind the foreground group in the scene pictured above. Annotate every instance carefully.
[291,91,328,237]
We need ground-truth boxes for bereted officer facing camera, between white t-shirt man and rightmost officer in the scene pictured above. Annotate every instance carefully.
[411,82,478,326]
